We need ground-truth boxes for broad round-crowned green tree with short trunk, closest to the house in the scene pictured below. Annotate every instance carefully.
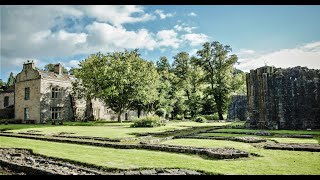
[74,50,159,122]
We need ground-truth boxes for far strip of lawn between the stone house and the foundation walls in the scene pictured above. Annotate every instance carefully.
[0,122,227,139]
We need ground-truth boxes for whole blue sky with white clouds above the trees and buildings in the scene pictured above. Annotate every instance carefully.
[0,5,320,81]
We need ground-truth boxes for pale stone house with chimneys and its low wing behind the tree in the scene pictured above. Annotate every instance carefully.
[14,62,136,123]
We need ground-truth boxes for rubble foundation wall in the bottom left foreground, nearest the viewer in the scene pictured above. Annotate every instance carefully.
[0,148,204,175]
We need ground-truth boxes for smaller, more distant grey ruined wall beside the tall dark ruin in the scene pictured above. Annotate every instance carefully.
[227,95,247,121]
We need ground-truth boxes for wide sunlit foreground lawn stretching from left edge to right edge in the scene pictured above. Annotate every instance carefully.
[0,137,320,175]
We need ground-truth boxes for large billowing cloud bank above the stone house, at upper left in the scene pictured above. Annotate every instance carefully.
[0,5,211,79]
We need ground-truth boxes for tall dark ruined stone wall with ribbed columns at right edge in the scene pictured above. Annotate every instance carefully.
[246,66,320,129]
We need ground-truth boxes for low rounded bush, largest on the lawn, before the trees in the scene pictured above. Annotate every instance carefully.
[130,116,165,127]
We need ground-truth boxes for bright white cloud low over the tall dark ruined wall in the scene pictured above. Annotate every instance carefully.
[236,41,320,72]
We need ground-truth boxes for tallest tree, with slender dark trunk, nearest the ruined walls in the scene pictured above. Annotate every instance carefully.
[197,41,238,119]
